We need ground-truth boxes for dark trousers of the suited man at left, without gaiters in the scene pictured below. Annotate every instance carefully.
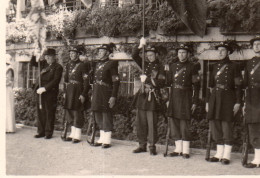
[37,92,57,136]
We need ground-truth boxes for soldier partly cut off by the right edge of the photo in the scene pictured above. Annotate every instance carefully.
[244,36,260,168]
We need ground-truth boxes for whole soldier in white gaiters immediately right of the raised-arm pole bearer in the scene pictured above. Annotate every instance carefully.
[168,44,200,159]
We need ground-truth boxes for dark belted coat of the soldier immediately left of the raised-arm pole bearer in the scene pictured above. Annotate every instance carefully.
[91,58,120,111]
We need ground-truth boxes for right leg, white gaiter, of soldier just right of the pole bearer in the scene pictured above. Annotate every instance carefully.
[180,119,190,159]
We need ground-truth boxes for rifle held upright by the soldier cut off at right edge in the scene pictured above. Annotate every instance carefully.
[241,91,249,166]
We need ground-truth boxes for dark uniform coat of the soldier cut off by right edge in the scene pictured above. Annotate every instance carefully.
[244,57,260,123]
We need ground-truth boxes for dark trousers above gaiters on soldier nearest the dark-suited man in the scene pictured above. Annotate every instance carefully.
[65,109,84,128]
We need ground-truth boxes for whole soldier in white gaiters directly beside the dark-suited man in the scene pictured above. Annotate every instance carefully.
[64,46,90,143]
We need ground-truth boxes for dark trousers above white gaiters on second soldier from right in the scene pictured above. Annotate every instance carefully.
[209,120,233,145]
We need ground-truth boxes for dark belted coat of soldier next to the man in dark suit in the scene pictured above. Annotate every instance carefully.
[64,60,90,110]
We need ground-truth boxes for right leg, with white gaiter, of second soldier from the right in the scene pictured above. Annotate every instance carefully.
[221,121,233,164]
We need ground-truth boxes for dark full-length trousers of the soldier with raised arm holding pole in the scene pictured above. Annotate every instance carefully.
[136,109,158,148]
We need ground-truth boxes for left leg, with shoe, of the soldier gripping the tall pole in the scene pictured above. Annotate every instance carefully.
[133,109,148,153]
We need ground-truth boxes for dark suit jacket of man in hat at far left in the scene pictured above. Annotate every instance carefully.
[30,56,63,94]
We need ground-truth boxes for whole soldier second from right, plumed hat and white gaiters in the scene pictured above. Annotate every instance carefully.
[206,42,242,165]
